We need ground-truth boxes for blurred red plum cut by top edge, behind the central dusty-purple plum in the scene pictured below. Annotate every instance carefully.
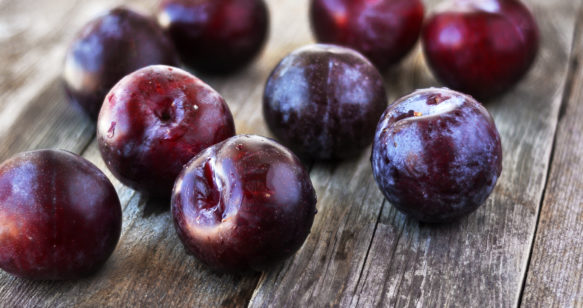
[310,0,425,71]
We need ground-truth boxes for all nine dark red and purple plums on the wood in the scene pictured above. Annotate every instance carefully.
[0,0,539,279]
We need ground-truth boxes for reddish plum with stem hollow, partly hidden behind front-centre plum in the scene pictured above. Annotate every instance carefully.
[97,65,235,198]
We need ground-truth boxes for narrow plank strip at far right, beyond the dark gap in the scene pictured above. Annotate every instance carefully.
[522,5,583,307]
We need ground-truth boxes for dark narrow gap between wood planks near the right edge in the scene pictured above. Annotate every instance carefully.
[516,2,583,307]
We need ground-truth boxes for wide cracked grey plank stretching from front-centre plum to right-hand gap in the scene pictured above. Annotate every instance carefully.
[250,0,578,307]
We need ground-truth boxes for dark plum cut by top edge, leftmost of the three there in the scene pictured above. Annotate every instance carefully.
[157,0,269,74]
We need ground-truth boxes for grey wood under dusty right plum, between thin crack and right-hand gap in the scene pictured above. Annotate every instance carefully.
[351,1,577,307]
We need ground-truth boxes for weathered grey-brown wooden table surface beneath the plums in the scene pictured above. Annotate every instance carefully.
[0,0,583,307]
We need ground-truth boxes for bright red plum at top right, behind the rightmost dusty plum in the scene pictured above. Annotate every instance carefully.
[423,0,539,99]
